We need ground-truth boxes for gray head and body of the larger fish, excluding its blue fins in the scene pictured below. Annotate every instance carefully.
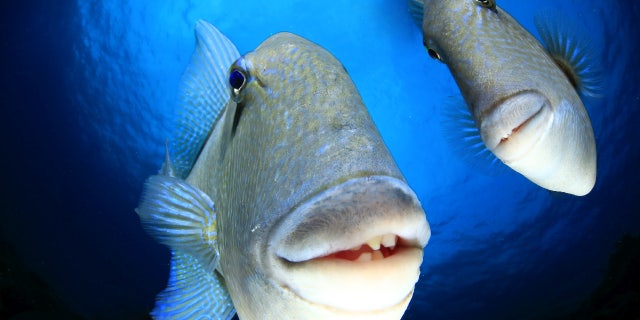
[213,33,430,319]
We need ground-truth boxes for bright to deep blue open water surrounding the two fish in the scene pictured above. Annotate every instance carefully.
[0,0,640,319]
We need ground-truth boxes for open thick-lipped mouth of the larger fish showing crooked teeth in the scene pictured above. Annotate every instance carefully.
[267,176,431,313]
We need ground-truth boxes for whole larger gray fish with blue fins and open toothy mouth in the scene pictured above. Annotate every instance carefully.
[136,21,431,319]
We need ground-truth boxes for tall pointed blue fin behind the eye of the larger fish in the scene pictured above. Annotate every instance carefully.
[172,20,240,178]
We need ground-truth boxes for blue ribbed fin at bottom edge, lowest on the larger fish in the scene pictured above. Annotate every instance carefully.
[151,251,236,319]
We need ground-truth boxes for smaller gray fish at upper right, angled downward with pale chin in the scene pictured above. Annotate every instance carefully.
[409,0,598,195]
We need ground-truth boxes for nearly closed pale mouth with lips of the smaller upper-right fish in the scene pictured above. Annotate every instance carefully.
[480,90,553,164]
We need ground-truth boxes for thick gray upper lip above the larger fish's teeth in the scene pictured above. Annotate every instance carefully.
[268,176,430,262]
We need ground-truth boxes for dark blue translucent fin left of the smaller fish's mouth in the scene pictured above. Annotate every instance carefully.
[441,97,507,176]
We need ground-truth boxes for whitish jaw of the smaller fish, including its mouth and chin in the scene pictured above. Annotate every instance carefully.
[480,91,596,196]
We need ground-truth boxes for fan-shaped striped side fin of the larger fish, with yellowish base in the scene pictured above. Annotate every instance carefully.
[136,175,219,270]
